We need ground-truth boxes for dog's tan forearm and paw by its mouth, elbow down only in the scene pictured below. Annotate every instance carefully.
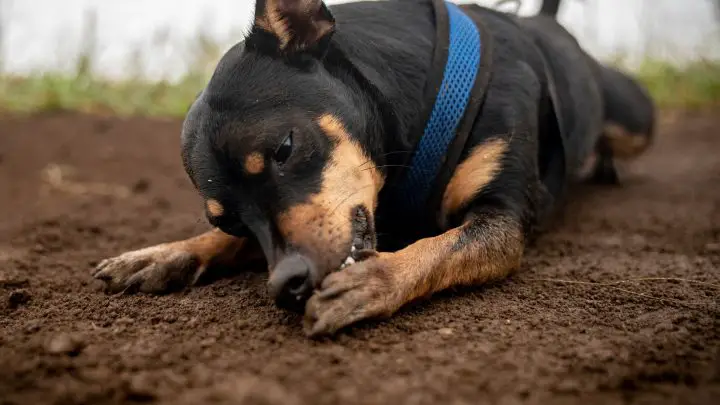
[305,211,524,336]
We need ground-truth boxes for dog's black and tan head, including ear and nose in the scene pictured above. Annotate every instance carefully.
[182,0,383,308]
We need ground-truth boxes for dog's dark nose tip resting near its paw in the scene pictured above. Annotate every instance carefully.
[268,254,313,312]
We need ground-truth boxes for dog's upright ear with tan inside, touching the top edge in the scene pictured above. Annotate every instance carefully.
[253,0,335,53]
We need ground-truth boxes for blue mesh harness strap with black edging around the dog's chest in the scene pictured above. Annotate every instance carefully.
[393,0,490,224]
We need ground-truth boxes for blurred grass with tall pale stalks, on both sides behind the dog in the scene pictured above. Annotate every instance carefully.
[0,0,720,117]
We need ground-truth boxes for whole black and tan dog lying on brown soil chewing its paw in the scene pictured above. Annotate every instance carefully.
[95,0,654,336]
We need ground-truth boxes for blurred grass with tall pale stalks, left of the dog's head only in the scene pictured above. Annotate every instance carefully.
[0,5,222,117]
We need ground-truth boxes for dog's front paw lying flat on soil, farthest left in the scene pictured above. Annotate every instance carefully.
[93,243,205,293]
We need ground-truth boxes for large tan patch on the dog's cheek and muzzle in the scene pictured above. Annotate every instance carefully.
[278,114,383,266]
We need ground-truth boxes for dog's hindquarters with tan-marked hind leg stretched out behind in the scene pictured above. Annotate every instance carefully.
[510,0,655,177]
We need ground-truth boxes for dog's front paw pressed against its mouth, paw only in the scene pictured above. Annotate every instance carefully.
[305,253,400,337]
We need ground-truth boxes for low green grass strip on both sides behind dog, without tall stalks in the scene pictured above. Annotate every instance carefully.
[0,60,720,117]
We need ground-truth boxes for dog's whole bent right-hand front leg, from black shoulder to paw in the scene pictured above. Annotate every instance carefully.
[305,61,552,336]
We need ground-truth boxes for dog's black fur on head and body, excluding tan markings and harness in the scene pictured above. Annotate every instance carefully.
[183,0,652,306]
